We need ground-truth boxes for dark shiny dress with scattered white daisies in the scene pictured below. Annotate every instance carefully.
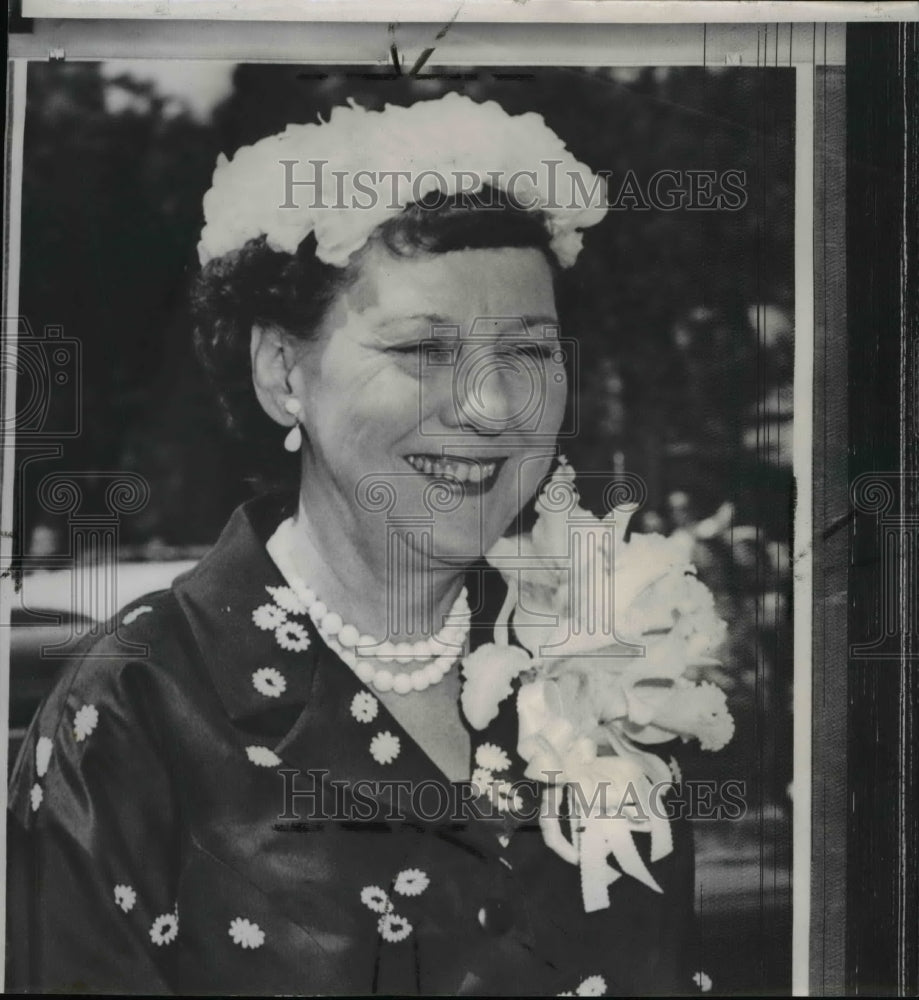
[7,497,695,995]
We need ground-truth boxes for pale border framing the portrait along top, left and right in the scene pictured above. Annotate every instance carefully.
[0,23,832,996]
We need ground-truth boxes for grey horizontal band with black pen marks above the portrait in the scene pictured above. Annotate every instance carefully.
[9,21,846,68]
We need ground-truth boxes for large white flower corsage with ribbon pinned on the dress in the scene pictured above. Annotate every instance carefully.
[462,459,734,912]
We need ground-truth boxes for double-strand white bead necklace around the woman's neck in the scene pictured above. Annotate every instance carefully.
[267,518,472,694]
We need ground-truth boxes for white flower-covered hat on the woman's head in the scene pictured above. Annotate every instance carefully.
[198,93,607,267]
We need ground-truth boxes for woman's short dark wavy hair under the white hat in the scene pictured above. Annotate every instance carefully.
[191,189,558,487]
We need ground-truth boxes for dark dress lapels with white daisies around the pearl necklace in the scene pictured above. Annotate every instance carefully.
[173,496,522,840]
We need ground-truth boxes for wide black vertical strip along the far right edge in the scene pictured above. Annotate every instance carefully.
[846,24,919,996]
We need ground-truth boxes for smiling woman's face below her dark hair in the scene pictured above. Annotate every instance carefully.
[290,237,567,561]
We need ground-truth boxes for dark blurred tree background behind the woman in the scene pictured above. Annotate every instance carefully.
[19,62,795,990]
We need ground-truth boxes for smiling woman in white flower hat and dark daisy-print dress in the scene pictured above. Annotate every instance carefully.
[10,95,700,995]
